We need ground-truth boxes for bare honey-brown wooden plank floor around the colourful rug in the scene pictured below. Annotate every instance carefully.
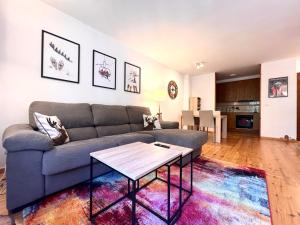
[0,133,300,225]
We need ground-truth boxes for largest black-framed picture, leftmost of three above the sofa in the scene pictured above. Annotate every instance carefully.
[41,30,80,83]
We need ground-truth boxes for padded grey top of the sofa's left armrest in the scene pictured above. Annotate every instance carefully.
[2,124,53,152]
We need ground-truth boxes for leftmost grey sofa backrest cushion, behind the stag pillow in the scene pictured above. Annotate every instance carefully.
[29,101,97,141]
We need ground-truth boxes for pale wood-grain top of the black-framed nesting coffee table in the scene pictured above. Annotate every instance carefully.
[90,142,188,180]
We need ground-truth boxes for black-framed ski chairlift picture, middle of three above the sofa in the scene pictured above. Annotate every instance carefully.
[93,50,117,89]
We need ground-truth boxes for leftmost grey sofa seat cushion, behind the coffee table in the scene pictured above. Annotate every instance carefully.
[42,138,118,175]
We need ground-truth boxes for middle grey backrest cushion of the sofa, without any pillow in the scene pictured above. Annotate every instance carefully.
[92,104,131,137]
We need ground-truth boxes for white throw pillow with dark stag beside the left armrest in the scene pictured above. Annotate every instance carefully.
[33,112,70,145]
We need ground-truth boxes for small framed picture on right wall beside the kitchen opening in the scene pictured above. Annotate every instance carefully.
[268,77,288,98]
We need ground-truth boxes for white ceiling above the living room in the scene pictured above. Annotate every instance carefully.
[43,0,300,75]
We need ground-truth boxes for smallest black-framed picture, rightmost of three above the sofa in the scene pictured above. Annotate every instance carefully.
[124,62,141,94]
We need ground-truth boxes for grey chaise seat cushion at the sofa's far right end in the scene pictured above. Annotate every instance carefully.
[139,129,207,149]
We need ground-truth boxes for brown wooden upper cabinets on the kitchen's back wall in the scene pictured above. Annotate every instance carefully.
[216,78,260,102]
